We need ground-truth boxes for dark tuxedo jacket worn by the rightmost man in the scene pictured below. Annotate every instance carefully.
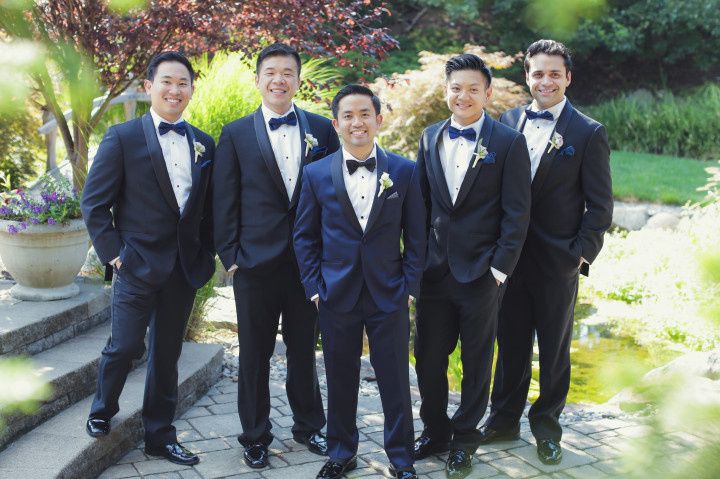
[500,101,613,277]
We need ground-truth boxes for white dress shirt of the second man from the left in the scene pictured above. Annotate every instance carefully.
[261,103,302,199]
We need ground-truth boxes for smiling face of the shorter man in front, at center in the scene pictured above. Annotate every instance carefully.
[333,95,382,150]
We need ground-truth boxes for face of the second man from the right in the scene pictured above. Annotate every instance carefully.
[445,70,492,126]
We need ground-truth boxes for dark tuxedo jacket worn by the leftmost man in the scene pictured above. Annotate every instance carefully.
[81,113,215,289]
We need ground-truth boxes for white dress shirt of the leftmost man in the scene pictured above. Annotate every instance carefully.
[150,108,194,214]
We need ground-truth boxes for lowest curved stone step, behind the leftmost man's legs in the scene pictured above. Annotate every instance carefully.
[0,343,223,479]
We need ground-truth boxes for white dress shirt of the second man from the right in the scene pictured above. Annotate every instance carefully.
[439,117,485,204]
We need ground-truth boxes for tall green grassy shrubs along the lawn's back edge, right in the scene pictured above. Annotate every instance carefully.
[587,83,720,159]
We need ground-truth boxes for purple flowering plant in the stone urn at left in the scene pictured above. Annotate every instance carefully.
[0,173,82,234]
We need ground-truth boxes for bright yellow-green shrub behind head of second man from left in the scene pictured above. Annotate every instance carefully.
[185,53,339,141]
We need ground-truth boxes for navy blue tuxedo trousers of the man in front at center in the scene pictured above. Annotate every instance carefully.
[319,285,414,471]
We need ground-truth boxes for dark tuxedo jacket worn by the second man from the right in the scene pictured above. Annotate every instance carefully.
[417,113,530,283]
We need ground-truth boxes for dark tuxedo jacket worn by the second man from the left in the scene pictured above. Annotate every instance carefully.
[213,107,340,270]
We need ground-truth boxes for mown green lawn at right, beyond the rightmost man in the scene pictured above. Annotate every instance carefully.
[610,151,717,205]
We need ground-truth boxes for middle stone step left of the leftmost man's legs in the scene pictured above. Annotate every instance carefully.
[0,321,119,451]
